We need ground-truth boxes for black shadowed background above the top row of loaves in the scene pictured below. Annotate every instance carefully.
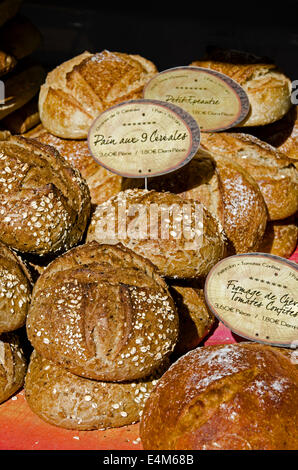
[21,0,298,80]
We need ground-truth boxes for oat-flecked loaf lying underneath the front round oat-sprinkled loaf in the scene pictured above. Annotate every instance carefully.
[25,351,169,431]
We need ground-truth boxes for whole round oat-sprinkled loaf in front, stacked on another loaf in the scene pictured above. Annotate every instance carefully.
[27,241,178,382]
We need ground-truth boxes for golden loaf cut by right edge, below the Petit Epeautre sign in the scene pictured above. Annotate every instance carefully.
[202,132,298,220]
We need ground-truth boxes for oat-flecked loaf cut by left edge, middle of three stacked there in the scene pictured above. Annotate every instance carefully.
[0,243,32,334]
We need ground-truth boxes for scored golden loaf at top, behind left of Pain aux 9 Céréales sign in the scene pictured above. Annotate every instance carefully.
[39,50,157,139]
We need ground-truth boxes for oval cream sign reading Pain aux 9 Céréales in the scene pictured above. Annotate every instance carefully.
[88,99,200,178]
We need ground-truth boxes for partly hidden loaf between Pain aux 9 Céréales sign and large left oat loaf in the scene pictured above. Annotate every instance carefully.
[32,128,122,204]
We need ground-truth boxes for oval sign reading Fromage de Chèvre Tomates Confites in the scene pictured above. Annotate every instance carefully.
[205,253,298,348]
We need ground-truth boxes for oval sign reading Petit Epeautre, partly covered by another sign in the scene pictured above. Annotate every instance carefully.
[144,67,250,132]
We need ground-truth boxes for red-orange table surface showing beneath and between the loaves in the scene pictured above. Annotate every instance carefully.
[0,247,298,450]
